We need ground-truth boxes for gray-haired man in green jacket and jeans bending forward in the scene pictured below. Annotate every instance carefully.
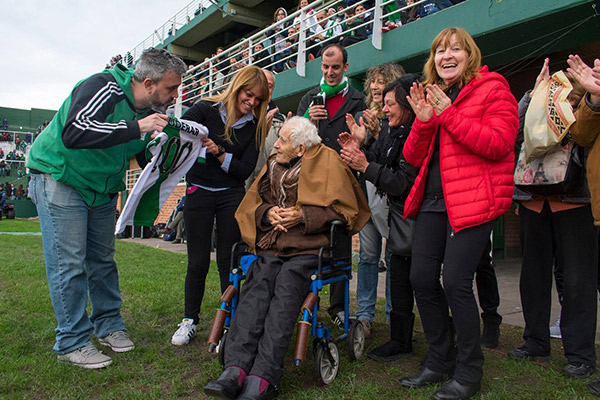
[27,49,187,368]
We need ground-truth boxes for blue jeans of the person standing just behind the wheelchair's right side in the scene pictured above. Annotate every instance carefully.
[356,219,391,322]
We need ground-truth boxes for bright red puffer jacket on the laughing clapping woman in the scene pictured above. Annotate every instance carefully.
[404,66,519,232]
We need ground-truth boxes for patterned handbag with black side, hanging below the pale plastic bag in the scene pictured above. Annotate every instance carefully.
[514,138,585,196]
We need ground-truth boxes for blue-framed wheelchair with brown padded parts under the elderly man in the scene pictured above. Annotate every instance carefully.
[208,220,365,385]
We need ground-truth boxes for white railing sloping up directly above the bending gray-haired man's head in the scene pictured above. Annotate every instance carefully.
[123,0,211,67]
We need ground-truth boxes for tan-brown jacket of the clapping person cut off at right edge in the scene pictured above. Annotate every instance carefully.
[571,94,600,226]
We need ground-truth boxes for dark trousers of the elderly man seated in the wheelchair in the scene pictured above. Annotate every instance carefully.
[225,255,317,386]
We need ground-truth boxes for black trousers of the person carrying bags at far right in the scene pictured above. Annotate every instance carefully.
[519,202,598,365]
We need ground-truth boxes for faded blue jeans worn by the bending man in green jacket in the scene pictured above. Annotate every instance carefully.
[29,174,125,354]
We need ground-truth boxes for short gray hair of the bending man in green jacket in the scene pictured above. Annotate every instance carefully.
[133,48,187,82]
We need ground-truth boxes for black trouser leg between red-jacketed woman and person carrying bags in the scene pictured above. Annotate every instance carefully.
[475,240,502,324]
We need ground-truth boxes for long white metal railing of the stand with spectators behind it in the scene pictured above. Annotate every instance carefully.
[175,0,429,111]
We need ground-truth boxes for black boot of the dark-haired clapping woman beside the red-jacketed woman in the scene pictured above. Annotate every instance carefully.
[367,311,415,361]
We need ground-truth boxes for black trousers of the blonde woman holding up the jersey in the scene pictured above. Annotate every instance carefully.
[183,186,245,324]
